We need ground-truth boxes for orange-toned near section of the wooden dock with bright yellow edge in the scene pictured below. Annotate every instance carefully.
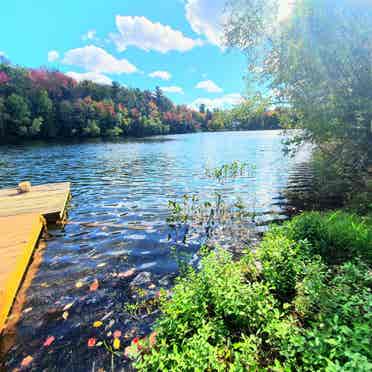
[0,213,45,332]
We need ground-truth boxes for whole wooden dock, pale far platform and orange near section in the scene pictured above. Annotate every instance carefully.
[0,183,70,333]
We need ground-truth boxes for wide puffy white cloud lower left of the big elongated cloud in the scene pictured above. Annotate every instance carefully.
[62,45,138,74]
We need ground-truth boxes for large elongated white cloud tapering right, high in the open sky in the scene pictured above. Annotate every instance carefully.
[110,15,203,53]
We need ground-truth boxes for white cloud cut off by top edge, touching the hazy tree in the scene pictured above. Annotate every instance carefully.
[185,0,226,48]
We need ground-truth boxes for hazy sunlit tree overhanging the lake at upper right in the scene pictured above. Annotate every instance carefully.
[226,0,372,189]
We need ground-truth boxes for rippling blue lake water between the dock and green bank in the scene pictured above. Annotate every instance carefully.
[0,131,308,371]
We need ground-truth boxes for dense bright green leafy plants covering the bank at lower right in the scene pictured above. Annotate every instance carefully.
[128,212,372,371]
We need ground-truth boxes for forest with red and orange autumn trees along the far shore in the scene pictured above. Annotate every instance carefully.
[0,60,280,142]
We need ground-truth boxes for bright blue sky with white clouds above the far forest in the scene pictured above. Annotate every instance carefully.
[0,0,250,107]
